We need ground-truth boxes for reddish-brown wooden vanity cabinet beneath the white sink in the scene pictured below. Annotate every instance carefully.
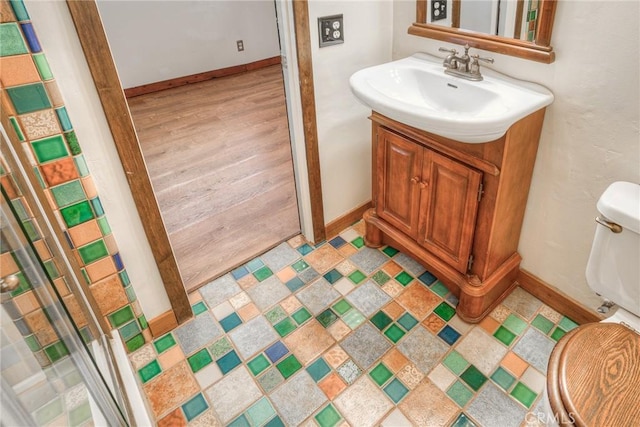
[364,110,544,323]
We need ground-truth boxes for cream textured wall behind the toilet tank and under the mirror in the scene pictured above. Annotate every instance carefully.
[393,0,640,307]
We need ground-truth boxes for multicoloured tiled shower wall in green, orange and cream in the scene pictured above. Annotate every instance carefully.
[0,0,151,364]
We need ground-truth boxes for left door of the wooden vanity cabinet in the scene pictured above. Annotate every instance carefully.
[376,128,424,239]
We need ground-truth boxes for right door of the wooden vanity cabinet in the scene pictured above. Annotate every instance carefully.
[418,148,482,273]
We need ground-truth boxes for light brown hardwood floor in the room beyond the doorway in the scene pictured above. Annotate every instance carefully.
[128,65,300,291]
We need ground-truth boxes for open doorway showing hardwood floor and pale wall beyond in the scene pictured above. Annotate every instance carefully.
[98,2,300,291]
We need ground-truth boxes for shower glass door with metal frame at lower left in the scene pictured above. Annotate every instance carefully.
[0,191,129,427]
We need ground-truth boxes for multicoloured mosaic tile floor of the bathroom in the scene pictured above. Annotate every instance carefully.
[130,223,576,427]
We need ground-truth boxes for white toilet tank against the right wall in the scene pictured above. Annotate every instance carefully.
[586,182,640,316]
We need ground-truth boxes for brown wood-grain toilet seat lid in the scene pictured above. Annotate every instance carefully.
[557,323,640,427]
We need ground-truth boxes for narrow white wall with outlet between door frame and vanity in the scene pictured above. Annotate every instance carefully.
[309,0,393,223]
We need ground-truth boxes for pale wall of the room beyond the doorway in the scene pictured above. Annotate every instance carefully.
[98,0,280,88]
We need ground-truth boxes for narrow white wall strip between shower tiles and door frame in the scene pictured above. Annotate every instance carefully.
[25,0,171,319]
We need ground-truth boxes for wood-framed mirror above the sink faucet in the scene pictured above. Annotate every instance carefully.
[409,0,557,63]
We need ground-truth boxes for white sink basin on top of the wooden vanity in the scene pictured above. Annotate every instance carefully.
[350,53,553,143]
